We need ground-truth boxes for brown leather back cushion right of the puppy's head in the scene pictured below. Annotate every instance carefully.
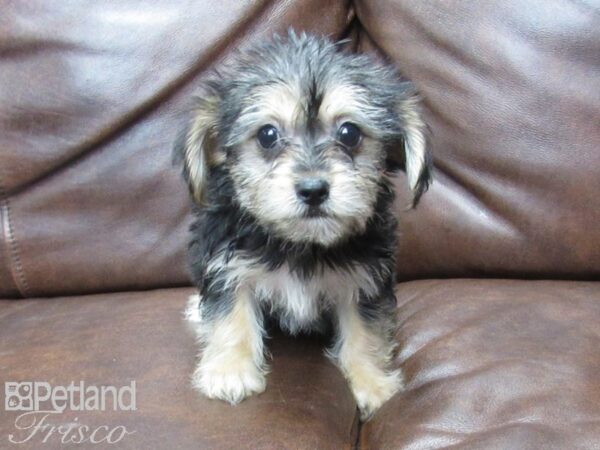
[356,0,600,279]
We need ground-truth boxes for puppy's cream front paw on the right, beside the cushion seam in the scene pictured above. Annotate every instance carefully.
[350,370,403,421]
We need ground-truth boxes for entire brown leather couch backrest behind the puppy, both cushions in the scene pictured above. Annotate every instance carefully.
[0,0,600,297]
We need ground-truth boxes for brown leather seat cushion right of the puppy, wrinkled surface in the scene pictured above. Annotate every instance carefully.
[361,280,600,450]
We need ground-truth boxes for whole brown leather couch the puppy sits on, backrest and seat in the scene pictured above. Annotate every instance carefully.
[0,0,600,449]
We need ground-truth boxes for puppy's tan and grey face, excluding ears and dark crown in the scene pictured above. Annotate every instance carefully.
[225,79,385,245]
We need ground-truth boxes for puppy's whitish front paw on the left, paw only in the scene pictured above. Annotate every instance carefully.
[192,361,267,405]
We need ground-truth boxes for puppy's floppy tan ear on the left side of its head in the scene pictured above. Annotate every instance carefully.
[173,95,225,205]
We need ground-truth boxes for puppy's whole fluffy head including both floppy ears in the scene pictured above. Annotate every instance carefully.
[175,33,429,246]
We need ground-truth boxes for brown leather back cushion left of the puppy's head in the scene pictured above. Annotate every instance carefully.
[0,0,351,296]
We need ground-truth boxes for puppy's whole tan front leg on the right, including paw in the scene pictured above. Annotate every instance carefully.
[330,301,402,420]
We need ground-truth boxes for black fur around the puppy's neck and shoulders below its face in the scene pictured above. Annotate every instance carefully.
[188,166,397,326]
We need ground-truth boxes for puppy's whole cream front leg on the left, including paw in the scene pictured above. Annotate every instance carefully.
[187,288,266,404]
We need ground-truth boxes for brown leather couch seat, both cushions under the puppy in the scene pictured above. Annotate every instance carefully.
[0,280,600,449]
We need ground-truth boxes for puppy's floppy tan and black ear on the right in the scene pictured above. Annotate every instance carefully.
[388,83,433,208]
